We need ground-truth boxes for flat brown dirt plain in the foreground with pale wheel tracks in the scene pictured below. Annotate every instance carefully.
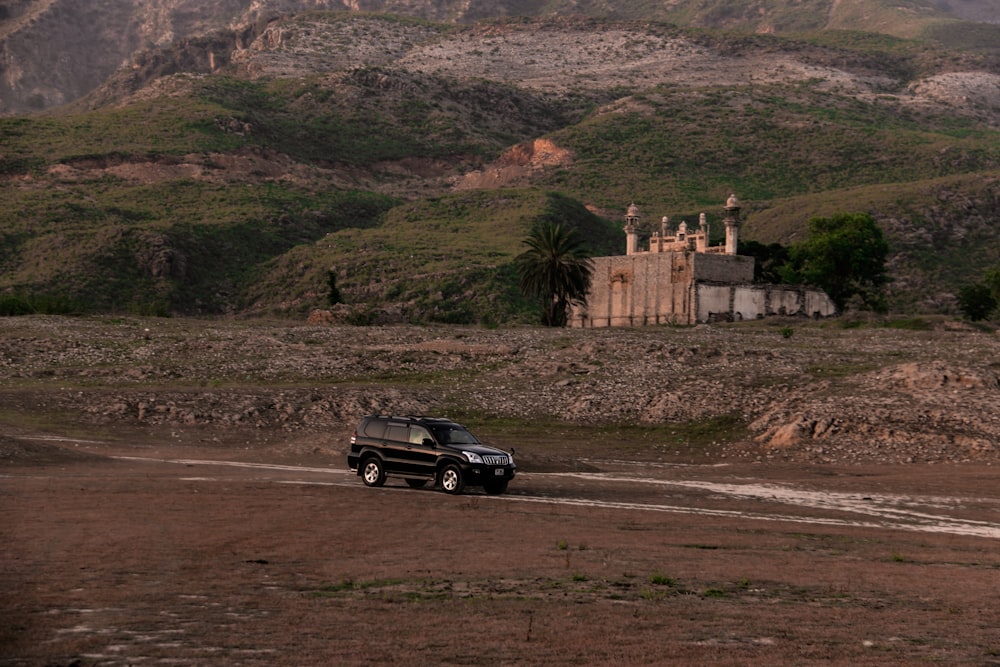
[0,428,1000,665]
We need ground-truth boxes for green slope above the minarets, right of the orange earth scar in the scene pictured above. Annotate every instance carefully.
[543,85,1000,212]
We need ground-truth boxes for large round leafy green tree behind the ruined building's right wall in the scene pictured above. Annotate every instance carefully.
[781,213,889,311]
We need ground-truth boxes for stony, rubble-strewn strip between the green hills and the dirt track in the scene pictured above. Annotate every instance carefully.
[0,317,1000,464]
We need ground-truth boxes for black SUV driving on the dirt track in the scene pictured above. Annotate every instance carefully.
[347,415,517,494]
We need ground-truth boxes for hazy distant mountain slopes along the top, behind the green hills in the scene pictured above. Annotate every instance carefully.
[0,0,1000,114]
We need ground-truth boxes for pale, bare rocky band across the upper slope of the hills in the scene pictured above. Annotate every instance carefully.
[231,15,1000,127]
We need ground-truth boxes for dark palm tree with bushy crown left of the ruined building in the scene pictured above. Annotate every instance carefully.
[514,222,594,327]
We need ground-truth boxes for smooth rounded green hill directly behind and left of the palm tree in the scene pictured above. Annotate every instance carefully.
[247,189,624,324]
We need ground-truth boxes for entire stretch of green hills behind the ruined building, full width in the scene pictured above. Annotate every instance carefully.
[0,12,1000,323]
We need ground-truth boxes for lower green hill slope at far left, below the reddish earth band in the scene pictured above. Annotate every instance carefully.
[0,180,394,315]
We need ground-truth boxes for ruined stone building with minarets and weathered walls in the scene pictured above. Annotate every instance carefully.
[569,196,837,327]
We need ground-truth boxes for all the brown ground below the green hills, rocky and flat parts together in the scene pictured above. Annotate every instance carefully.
[0,317,1000,667]
